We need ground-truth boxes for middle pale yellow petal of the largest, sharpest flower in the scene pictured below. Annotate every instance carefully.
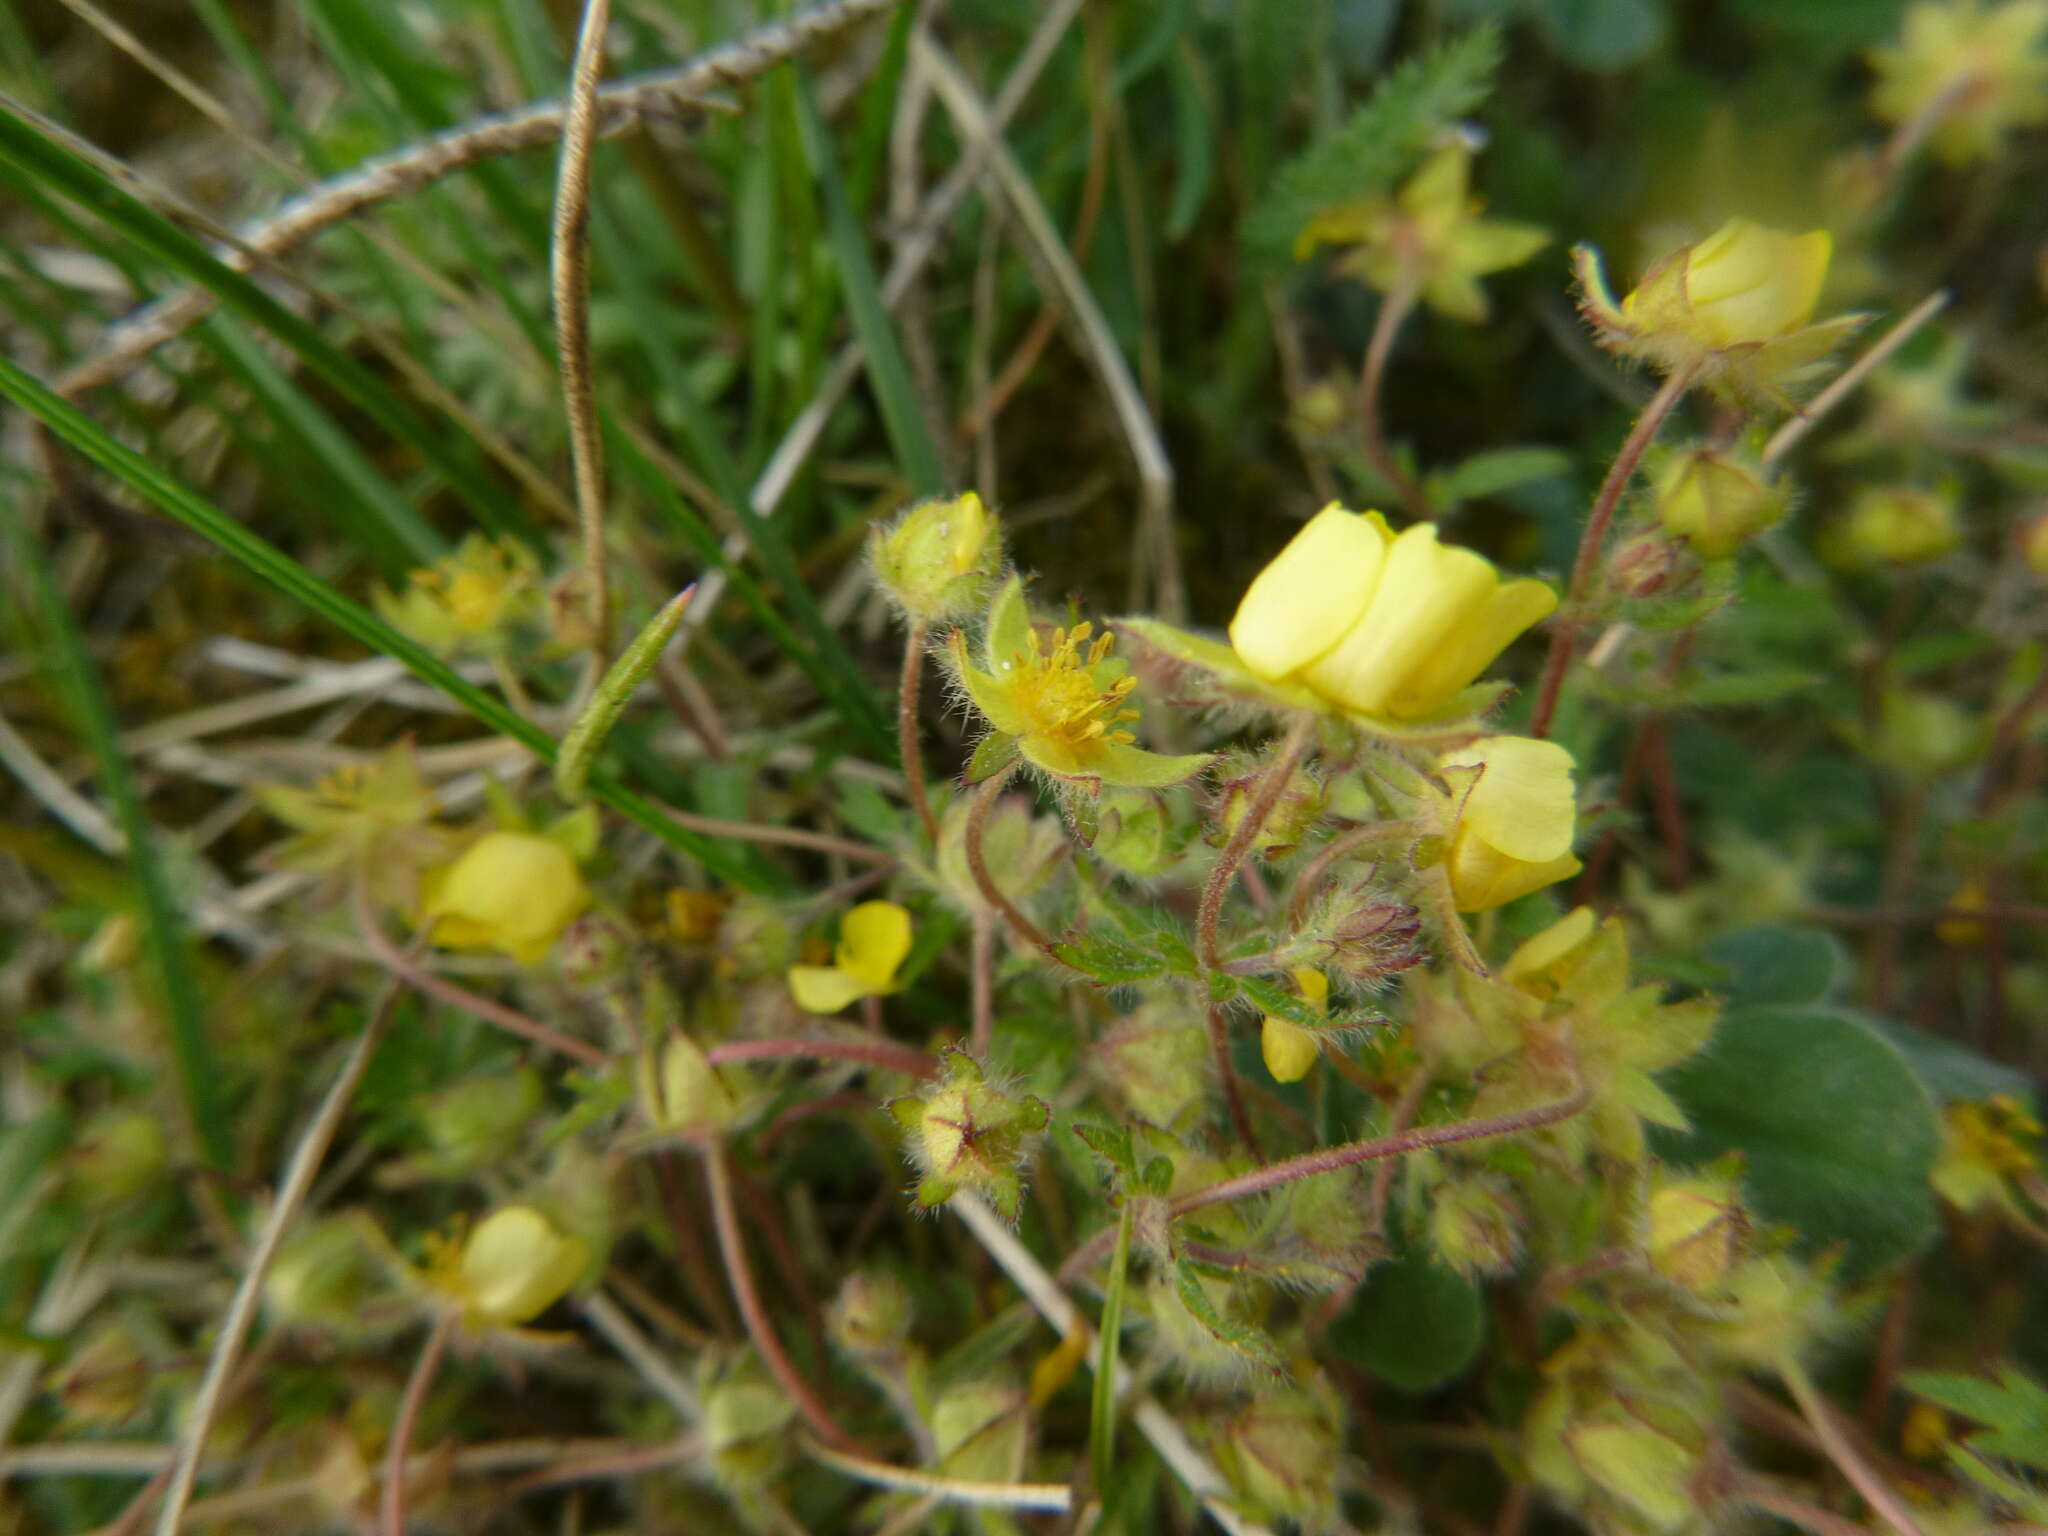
[1303,522,1499,715]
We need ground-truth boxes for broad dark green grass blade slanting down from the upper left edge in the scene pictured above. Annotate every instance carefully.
[0,111,539,543]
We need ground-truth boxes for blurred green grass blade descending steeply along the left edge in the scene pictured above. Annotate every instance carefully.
[0,512,233,1171]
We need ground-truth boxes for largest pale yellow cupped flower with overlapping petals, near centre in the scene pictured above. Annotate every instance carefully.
[1231,504,1556,721]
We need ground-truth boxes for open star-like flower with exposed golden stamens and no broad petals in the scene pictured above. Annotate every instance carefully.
[952,575,1212,788]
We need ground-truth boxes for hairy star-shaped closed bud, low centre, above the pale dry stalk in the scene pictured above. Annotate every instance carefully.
[889,1051,1053,1221]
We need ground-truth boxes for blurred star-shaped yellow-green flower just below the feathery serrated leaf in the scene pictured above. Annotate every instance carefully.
[1294,137,1550,322]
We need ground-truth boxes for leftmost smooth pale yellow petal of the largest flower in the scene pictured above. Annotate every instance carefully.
[1231,502,1393,680]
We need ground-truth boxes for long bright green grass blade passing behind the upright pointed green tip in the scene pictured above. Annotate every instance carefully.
[0,346,762,891]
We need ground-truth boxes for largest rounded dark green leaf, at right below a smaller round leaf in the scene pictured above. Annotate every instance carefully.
[1651,1008,1942,1274]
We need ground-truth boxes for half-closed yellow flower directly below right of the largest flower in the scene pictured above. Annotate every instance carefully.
[1438,735,1579,911]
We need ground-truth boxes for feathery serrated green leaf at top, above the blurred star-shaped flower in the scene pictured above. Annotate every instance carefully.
[1245,27,1501,262]
